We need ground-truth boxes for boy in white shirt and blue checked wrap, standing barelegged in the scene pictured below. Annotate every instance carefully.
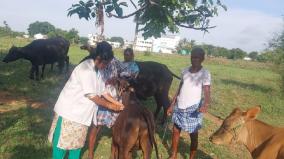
[167,48,211,159]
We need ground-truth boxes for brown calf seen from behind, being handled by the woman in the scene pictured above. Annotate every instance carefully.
[111,79,159,159]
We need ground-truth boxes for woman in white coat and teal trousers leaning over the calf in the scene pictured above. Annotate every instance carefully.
[49,42,123,159]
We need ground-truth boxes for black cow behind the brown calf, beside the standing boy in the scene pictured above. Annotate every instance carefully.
[134,61,180,123]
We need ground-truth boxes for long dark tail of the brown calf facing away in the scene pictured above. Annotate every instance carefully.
[143,108,160,159]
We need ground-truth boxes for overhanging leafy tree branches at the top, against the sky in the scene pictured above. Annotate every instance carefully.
[68,0,226,38]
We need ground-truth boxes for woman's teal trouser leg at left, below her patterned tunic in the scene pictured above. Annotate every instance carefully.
[52,117,66,159]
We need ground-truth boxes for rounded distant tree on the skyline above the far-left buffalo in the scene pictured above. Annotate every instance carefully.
[28,21,55,36]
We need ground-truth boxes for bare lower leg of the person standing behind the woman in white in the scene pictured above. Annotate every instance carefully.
[89,125,102,159]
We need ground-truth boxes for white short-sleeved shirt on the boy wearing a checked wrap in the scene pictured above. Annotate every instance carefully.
[177,68,211,109]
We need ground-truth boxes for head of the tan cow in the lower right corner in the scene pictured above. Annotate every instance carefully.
[209,106,260,145]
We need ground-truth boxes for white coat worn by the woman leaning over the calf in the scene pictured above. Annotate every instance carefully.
[54,59,105,126]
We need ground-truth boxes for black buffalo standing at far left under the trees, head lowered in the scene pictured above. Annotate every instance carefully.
[3,37,70,80]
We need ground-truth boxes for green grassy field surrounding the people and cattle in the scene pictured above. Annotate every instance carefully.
[0,38,284,159]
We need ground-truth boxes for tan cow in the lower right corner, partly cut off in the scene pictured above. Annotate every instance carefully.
[210,106,284,159]
